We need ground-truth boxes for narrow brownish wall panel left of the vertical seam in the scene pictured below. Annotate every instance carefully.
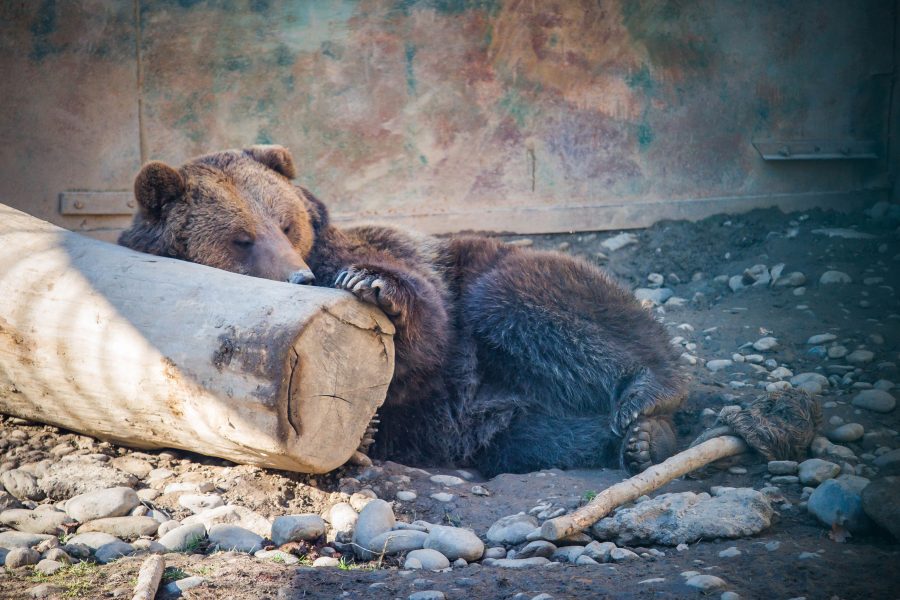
[0,0,140,238]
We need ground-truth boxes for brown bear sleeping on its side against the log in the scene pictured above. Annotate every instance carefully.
[119,146,684,476]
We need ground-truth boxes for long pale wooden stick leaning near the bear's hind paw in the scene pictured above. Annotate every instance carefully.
[541,435,749,541]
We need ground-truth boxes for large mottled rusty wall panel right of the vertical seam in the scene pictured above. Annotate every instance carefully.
[142,0,893,231]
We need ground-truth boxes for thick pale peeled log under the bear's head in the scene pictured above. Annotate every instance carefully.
[0,204,394,473]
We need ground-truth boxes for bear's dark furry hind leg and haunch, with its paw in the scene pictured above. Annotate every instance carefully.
[463,252,683,470]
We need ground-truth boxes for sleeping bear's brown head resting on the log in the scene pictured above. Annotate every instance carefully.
[119,146,328,284]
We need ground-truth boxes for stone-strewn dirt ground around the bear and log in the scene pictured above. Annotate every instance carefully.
[0,205,900,600]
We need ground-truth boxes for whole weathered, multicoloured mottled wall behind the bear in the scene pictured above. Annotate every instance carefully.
[0,0,895,237]
